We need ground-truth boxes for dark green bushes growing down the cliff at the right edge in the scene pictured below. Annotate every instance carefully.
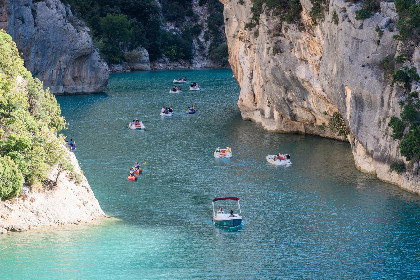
[380,0,420,174]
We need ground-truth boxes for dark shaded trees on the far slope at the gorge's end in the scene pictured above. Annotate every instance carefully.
[63,0,228,63]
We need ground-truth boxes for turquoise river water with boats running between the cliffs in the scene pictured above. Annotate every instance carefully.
[0,70,420,279]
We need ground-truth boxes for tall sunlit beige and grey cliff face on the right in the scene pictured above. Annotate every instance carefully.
[222,0,420,194]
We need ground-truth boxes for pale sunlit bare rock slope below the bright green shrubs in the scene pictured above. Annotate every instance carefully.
[0,149,105,233]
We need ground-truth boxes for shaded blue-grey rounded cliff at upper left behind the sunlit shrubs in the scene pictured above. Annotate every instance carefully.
[0,0,109,94]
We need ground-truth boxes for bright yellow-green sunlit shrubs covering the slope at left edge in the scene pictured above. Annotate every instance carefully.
[0,31,65,199]
